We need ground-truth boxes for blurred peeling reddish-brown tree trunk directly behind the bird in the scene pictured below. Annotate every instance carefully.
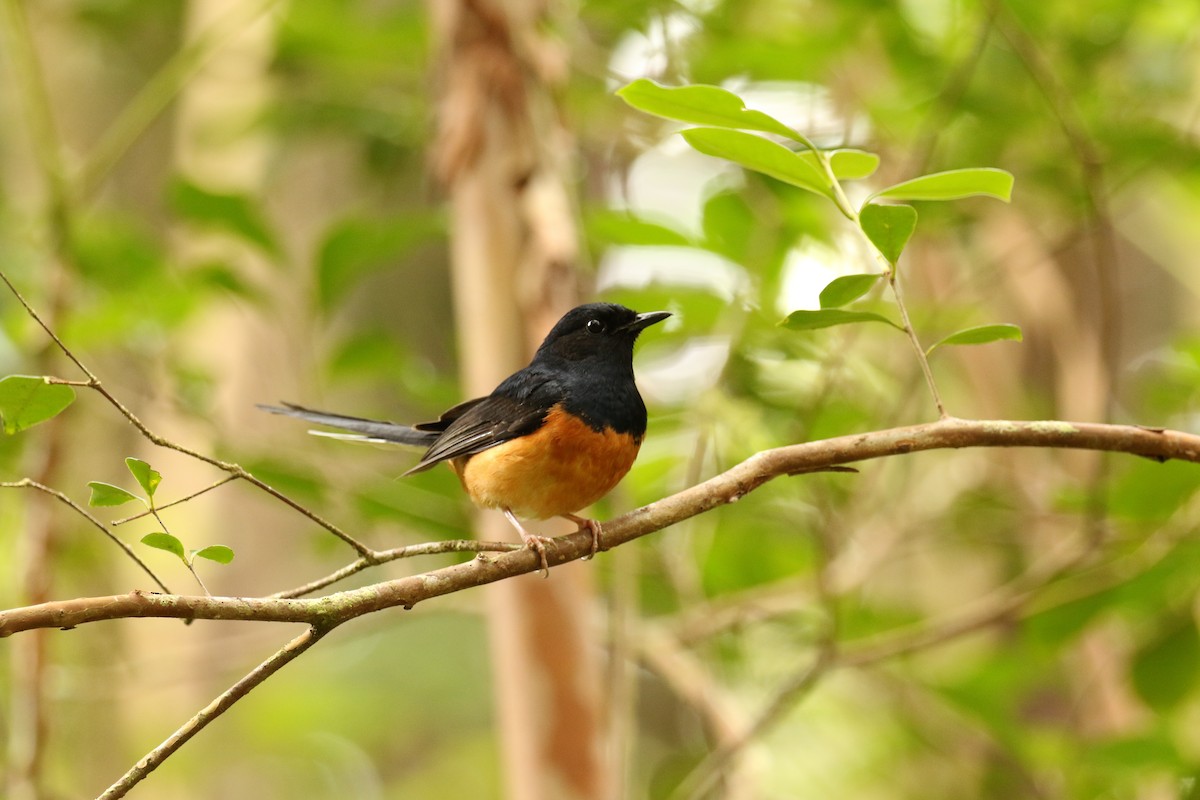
[430,0,606,800]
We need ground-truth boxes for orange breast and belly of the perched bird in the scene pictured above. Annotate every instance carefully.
[450,405,641,519]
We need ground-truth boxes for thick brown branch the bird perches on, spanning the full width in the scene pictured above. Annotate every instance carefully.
[0,417,1200,637]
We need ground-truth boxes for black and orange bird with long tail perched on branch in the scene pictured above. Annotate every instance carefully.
[259,302,671,576]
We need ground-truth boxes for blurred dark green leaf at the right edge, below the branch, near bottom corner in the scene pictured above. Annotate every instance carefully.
[1130,610,1200,712]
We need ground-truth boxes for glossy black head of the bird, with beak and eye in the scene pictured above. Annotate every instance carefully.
[536,302,671,369]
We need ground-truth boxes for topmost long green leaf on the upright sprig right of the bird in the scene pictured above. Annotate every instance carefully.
[617,78,808,144]
